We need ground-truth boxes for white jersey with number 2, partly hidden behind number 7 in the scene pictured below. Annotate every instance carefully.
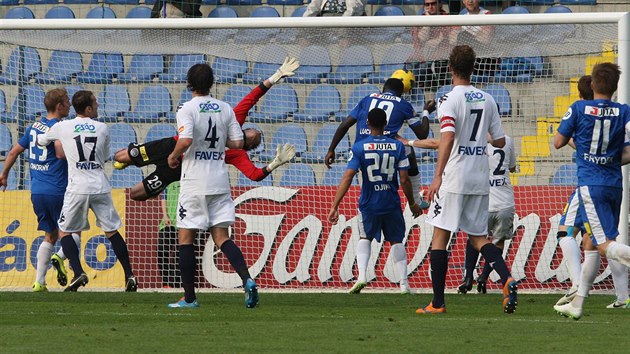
[488,135,516,213]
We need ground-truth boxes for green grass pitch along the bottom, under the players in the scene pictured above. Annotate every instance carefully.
[0,289,630,353]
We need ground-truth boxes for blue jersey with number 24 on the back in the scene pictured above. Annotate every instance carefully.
[348,135,409,214]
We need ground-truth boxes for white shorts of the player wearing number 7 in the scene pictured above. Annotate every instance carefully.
[427,191,490,236]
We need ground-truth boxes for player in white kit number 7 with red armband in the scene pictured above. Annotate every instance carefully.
[416,45,518,314]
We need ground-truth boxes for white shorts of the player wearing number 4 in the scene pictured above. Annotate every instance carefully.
[177,193,235,230]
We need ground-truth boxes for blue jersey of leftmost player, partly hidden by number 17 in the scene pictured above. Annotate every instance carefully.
[18,118,68,195]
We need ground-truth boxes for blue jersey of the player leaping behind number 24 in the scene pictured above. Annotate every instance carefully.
[350,92,420,141]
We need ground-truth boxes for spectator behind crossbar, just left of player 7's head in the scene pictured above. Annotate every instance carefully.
[407,0,457,90]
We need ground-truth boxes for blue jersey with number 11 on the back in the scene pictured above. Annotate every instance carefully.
[558,99,630,188]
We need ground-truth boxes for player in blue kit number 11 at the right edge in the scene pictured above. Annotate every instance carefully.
[554,63,630,320]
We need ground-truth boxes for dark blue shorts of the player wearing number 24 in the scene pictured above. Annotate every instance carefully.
[359,208,405,243]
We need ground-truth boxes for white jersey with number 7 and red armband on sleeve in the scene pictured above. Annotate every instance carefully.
[437,85,505,194]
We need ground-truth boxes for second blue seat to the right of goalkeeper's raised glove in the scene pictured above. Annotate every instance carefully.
[328,45,374,85]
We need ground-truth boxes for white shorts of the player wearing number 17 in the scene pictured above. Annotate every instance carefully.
[59,191,122,232]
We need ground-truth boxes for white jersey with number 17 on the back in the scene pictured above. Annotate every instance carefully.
[37,117,112,194]
